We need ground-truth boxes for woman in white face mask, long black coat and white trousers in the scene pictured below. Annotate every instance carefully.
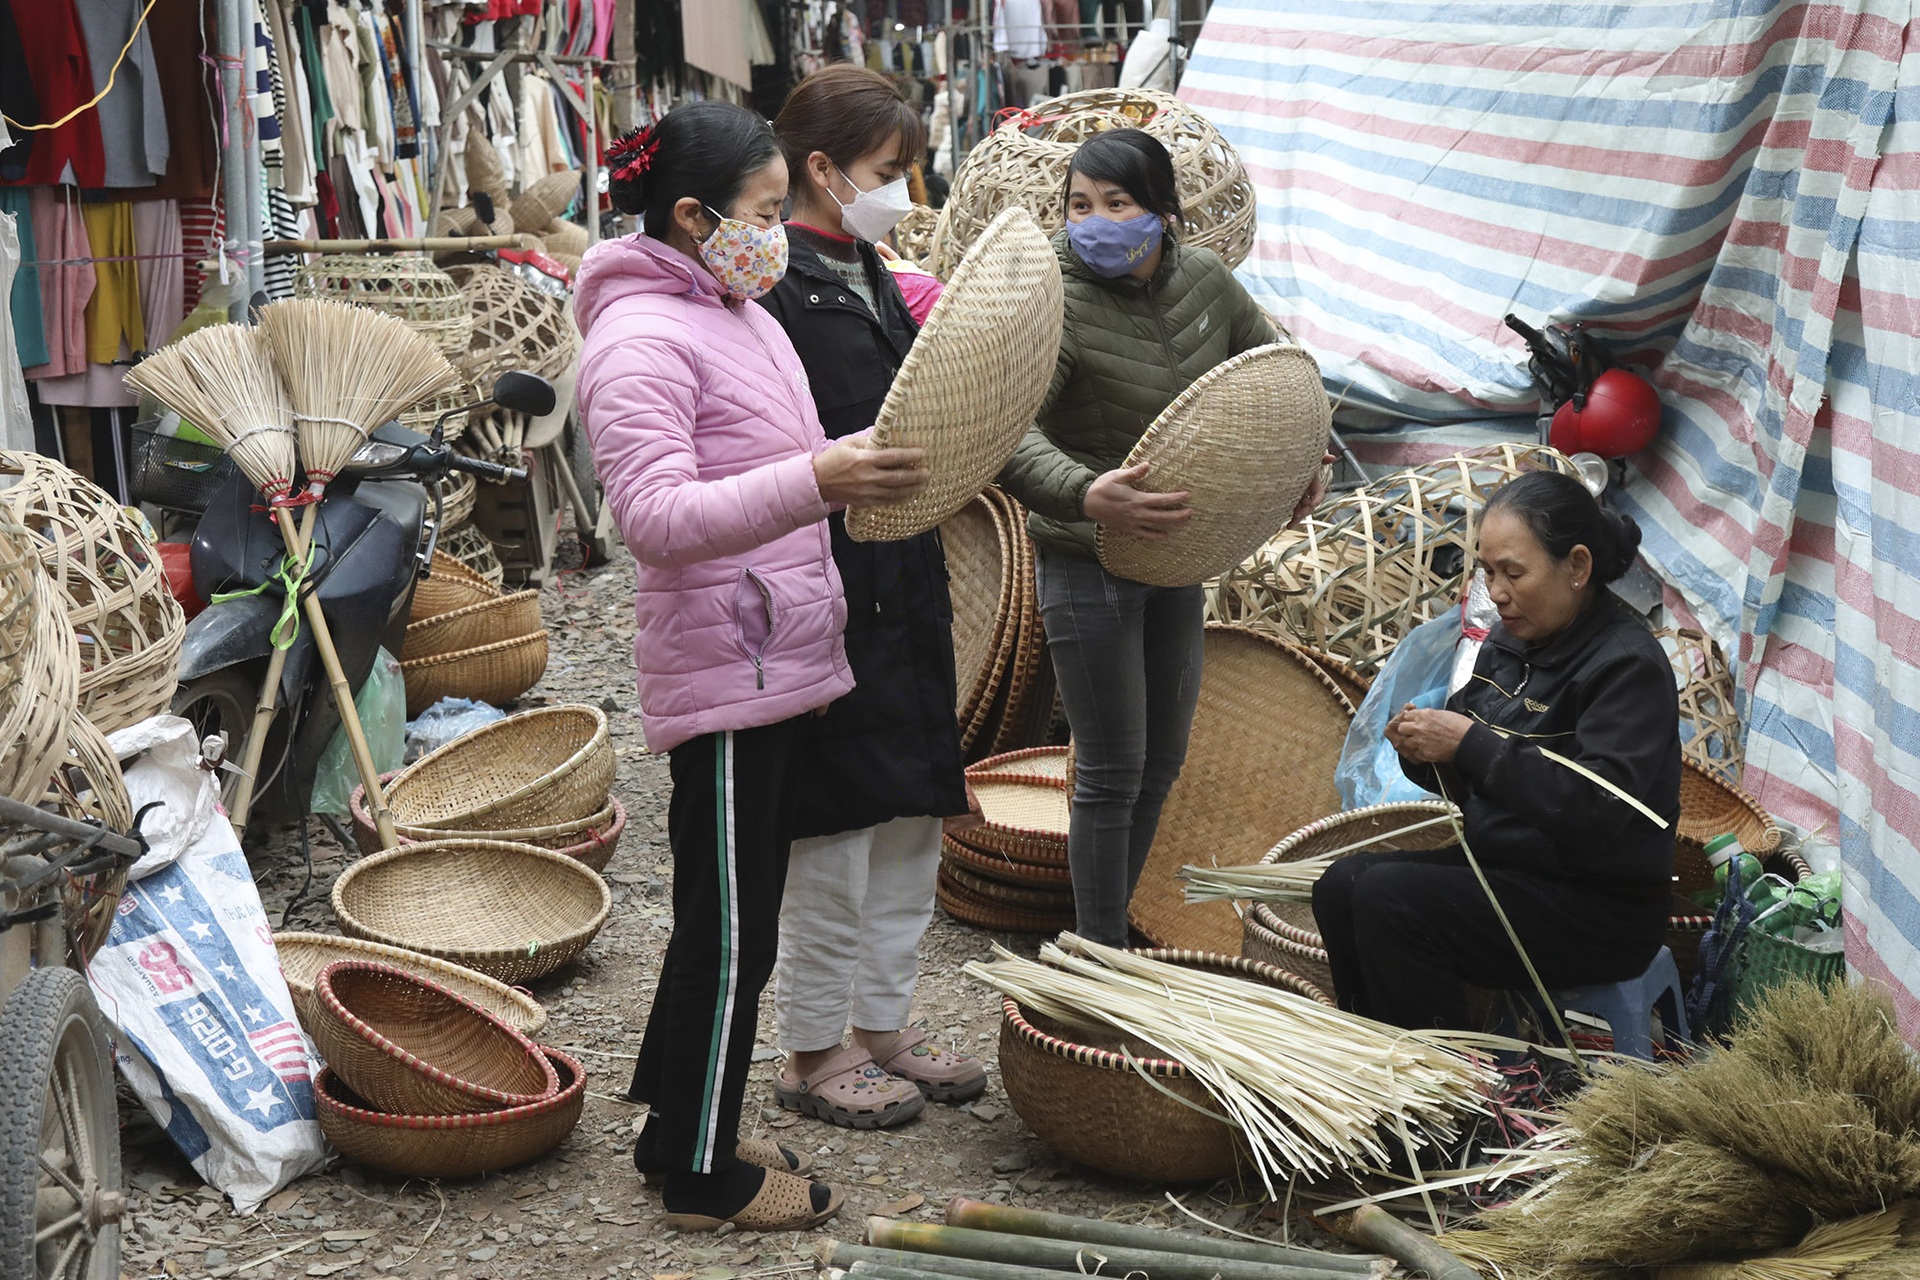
[760,65,987,1128]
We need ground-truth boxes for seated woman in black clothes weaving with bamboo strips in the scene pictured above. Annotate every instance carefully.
[1313,472,1680,1031]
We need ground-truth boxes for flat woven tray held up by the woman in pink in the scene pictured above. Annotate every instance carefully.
[847,209,1062,541]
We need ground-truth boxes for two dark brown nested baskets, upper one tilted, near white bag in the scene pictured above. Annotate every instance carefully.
[305,960,586,1178]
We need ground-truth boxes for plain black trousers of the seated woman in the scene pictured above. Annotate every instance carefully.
[1313,846,1668,1031]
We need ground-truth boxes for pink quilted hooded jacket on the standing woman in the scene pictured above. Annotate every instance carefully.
[574,236,852,752]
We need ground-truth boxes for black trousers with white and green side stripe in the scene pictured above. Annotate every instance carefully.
[628,718,806,1173]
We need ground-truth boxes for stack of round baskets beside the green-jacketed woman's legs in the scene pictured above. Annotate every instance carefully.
[939,747,1073,933]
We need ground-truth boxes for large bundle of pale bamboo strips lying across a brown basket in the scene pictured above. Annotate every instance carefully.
[966,933,1500,1194]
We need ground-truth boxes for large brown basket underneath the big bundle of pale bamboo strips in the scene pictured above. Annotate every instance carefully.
[1000,950,1332,1182]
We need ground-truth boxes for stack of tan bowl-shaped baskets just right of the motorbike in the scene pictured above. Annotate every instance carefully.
[399,551,547,718]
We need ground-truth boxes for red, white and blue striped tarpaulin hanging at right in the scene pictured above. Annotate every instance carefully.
[1181,0,1920,1044]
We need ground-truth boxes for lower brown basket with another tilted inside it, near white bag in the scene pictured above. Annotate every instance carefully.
[313,1046,588,1178]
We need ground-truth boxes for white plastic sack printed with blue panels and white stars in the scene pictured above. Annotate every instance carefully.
[86,819,326,1213]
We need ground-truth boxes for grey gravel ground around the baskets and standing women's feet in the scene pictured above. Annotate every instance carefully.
[121,549,1359,1280]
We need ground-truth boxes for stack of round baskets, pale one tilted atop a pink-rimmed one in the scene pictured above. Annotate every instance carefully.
[349,706,626,871]
